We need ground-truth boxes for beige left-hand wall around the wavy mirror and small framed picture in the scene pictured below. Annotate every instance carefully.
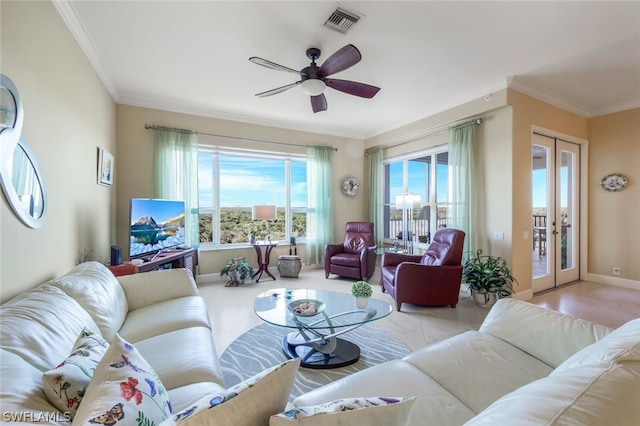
[0,0,117,301]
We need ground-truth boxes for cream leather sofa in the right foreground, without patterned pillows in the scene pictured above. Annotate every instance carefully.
[293,299,640,426]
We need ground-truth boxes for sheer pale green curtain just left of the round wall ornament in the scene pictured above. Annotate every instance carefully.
[306,147,333,265]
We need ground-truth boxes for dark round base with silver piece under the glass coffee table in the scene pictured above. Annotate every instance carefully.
[282,332,360,369]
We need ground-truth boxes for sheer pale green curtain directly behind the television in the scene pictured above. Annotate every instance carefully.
[153,127,200,247]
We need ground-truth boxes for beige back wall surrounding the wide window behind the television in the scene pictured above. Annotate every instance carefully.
[116,105,368,274]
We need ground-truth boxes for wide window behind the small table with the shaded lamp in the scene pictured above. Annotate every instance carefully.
[198,146,307,247]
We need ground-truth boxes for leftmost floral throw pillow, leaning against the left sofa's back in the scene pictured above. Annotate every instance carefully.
[42,327,109,418]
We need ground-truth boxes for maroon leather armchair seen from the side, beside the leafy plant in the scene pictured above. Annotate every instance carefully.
[381,228,464,311]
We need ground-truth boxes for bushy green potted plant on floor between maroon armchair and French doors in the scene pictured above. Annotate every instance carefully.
[462,249,518,307]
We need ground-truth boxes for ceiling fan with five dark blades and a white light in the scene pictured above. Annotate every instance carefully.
[249,44,380,112]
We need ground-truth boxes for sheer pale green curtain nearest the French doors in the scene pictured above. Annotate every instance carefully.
[449,122,477,253]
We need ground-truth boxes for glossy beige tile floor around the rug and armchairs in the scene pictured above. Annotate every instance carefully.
[198,268,640,355]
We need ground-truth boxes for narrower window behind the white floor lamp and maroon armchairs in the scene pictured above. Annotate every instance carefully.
[384,148,449,243]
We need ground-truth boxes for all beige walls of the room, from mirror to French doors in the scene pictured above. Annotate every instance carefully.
[0,0,640,301]
